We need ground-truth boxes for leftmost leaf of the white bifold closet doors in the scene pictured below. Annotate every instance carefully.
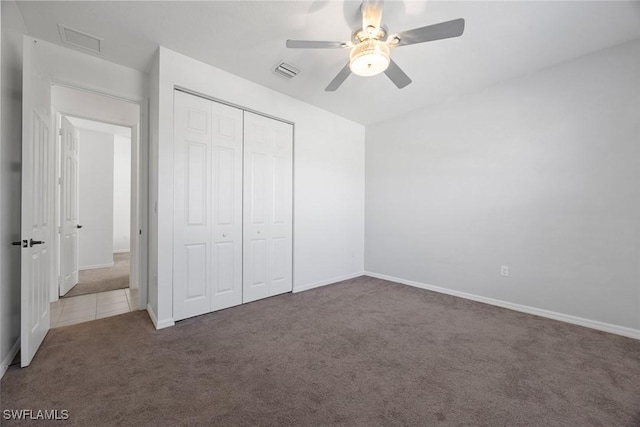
[173,91,211,320]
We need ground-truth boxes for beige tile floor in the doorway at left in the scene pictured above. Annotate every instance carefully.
[51,288,138,328]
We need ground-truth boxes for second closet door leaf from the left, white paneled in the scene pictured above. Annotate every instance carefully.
[211,102,243,310]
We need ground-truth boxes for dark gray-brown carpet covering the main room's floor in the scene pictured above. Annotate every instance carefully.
[0,277,640,427]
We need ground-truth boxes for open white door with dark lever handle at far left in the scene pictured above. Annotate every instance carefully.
[20,37,52,367]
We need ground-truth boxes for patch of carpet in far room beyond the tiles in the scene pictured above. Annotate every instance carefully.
[64,252,131,298]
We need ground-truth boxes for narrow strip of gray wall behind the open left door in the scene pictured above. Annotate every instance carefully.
[0,1,27,372]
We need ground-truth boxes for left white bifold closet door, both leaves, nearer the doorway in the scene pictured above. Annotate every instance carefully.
[173,91,243,320]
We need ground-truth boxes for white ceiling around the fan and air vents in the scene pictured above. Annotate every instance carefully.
[13,0,640,124]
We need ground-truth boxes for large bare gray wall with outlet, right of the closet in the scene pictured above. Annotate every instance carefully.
[365,41,640,329]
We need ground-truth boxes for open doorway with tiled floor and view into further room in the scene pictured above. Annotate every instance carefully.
[50,86,141,328]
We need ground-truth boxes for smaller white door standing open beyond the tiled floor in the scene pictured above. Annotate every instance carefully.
[60,116,82,295]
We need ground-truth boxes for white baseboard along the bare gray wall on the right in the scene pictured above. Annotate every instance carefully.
[364,271,640,340]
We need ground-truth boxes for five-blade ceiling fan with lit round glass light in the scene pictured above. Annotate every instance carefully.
[287,0,464,92]
